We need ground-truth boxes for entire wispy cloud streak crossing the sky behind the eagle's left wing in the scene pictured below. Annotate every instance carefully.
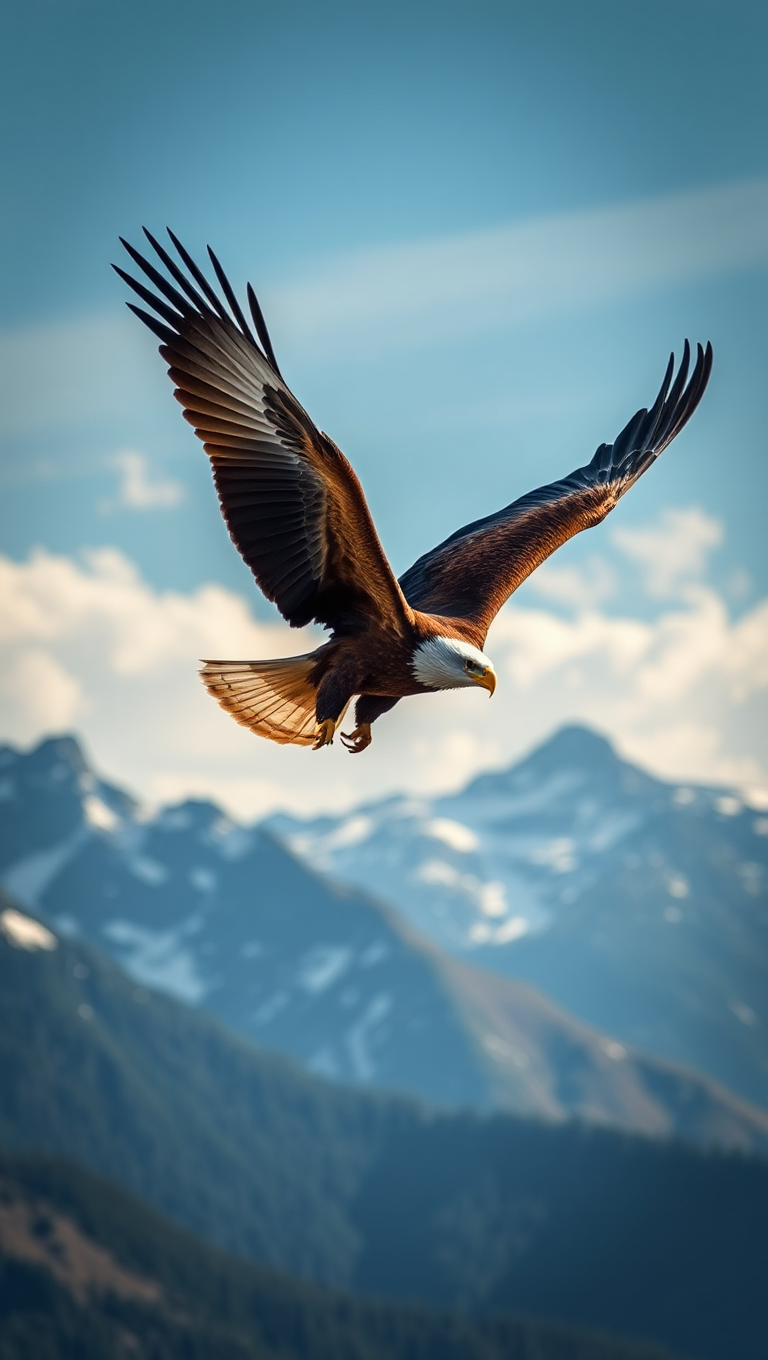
[0,180,768,432]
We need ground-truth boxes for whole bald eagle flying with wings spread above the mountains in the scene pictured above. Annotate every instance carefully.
[113,228,712,755]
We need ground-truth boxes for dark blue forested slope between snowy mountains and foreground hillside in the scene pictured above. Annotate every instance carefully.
[0,902,768,1360]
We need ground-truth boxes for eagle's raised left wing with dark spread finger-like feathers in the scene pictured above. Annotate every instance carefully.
[114,231,411,632]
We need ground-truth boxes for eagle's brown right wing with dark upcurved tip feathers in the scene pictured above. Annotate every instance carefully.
[400,340,712,645]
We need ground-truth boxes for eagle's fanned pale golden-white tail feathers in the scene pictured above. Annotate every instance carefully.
[200,653,317,747]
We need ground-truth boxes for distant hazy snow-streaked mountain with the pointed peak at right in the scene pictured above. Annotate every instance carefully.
[266,728,768,1106]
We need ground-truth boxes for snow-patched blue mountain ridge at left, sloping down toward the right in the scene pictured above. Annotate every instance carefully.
[0,738,768,1149]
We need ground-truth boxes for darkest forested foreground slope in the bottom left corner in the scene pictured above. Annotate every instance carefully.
[0,1156,682,1360]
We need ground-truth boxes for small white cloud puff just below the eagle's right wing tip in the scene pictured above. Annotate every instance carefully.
[612,507,723,597]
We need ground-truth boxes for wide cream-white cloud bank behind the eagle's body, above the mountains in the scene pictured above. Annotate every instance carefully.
[0,535,768,817]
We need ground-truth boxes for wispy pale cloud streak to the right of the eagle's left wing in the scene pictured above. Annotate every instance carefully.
[269,180,768,348]
